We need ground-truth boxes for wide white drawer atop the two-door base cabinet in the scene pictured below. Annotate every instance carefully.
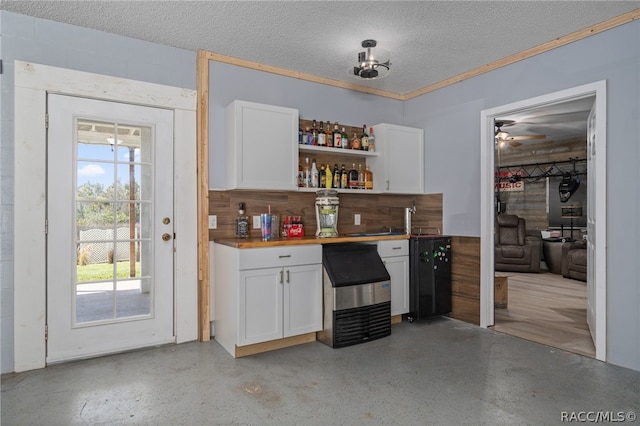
[239,244,322,270]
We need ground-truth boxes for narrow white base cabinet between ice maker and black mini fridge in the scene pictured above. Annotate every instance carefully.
[378,240,409,315]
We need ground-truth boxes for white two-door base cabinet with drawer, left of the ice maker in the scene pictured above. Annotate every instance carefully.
[214,244,322,356]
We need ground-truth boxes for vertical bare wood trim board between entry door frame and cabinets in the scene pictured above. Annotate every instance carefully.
[196,50,211,342]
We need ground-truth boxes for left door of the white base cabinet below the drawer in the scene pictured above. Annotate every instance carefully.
[238,268,284,346]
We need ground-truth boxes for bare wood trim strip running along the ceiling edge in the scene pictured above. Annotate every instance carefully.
[198,8,640,101]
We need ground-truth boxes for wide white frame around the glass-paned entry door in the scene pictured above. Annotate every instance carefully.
[14,61,198,372]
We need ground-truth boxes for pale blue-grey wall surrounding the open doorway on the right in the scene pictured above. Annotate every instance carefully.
[404,21,640,370]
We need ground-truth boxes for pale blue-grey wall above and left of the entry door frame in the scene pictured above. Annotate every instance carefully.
[0,11,196,373]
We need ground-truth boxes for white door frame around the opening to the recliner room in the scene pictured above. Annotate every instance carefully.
[480,80,607,361]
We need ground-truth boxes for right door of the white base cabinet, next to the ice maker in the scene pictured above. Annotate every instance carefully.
[283,264,322,337]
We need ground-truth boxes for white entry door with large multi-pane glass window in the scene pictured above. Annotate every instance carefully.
[47,95,175,363]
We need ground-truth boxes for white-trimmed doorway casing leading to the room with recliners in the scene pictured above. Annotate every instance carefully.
[480,81,606,361]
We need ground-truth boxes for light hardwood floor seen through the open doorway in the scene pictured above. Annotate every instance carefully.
[493,272,595,358]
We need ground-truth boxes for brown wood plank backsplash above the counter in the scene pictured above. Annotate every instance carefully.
[209,190,442,240]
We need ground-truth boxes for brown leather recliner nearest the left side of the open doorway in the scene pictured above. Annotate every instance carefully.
[494,214,542,272]
